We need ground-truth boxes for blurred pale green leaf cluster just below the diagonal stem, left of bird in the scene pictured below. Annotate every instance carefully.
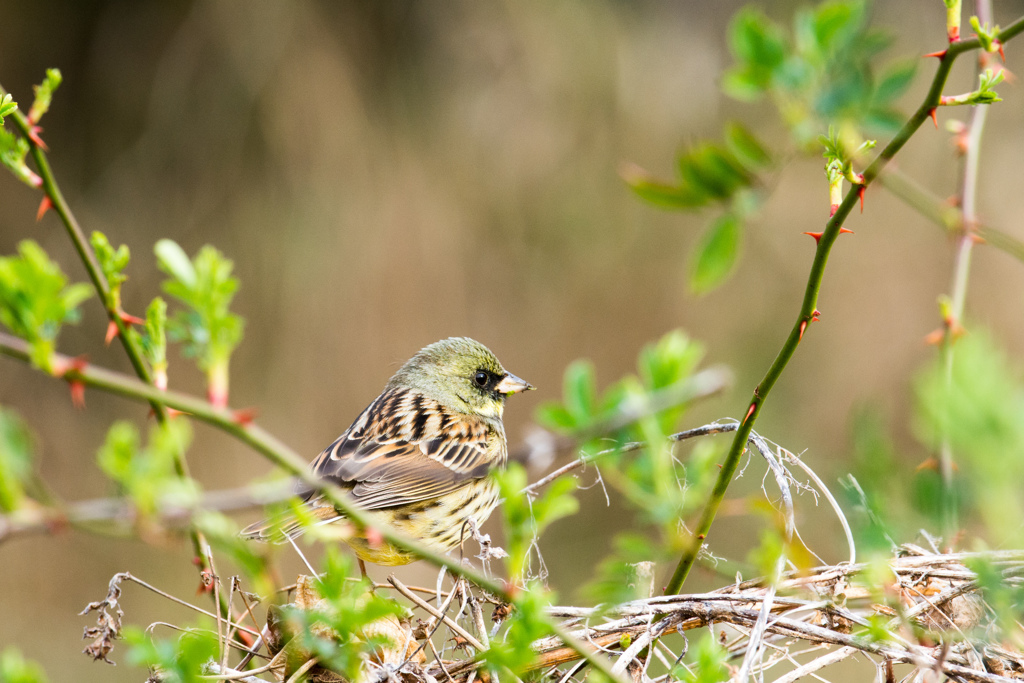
[97,420,199,515]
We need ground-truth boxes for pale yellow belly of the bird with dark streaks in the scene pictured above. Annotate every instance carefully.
[347,477,498,566]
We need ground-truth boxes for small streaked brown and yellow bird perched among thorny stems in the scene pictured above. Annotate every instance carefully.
[236,337,534,566]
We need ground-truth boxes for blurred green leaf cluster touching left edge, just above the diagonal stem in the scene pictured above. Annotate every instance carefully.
[0,240,92,373]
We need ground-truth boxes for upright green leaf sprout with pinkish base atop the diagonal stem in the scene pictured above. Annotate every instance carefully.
[156,240,244,403]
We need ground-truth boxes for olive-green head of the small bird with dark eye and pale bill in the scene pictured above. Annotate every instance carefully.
[388,337,534,419]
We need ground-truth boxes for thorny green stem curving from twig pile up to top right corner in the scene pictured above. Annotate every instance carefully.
[665,16,1024,595]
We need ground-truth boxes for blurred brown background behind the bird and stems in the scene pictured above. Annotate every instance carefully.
[0,0,1024,682]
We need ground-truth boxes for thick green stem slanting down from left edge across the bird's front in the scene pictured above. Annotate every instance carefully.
[0,333,625,683]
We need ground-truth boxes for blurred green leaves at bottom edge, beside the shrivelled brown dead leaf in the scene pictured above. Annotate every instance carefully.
[122,627,217,683]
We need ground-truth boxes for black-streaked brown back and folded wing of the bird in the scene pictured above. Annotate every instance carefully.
[311,389,506,510]
